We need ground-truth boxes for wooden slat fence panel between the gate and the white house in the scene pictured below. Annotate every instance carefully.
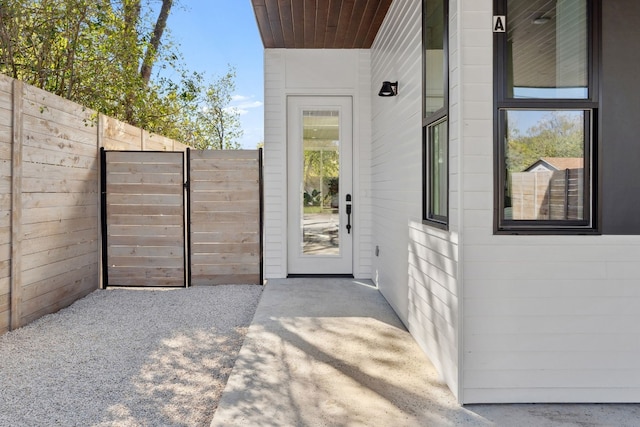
[189,150,262,285]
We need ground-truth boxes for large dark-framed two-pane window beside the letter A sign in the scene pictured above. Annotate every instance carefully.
[495,0,598,233]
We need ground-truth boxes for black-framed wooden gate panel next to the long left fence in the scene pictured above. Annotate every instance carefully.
[102,151,186,286]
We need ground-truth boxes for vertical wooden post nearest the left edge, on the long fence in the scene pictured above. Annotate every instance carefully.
[9,80,24,330]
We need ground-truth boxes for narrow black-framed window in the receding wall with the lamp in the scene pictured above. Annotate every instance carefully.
[422,0,449,228]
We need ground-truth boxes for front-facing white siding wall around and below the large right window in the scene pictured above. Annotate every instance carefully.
[460,0,640,403]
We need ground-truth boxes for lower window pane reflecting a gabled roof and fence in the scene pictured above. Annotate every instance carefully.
[504,110,588,220]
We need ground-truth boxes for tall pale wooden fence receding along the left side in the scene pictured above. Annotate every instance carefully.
[0,76,186,333]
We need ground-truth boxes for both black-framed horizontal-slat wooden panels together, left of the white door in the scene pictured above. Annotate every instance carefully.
[101,150,262,287]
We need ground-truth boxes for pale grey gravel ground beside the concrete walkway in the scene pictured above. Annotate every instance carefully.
[0,285,262,427]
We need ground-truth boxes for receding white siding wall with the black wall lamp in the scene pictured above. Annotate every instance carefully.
[371,0,460,402]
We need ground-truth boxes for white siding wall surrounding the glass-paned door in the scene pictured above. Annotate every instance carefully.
[264,49,371,279]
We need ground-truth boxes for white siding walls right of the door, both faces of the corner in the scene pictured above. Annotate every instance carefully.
[371,0,640,403]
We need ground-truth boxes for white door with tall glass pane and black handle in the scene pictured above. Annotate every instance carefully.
[287,96,355,274]
